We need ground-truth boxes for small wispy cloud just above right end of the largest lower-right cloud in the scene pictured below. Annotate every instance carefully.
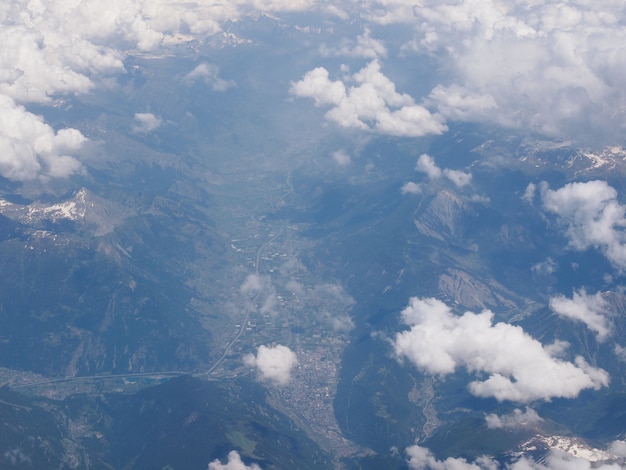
[550,289,610,341]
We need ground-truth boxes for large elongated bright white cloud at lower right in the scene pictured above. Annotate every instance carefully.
[392,297,609,402]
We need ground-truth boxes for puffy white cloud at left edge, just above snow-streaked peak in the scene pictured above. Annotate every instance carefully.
[0,95,86,181]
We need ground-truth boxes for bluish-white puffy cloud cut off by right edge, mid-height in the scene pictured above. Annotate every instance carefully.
[541,180,626,270]
